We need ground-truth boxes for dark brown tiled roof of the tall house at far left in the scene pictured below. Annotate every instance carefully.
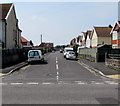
[0,3,12,19]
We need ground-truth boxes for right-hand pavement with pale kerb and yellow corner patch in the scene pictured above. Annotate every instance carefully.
[78,58,120,79]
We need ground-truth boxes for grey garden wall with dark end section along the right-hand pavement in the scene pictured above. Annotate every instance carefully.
[78,45,120,62]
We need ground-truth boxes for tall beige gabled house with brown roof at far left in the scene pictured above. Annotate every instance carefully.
[0,3,22,49]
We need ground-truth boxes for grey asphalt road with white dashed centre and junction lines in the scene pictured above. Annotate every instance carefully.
[1,52,118,104]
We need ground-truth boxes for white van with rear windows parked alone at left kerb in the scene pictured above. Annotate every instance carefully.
[28,50,44,63]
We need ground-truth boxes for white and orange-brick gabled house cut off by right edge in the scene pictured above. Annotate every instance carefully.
[111,21,120,48]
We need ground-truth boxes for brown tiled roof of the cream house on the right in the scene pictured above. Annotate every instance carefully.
[94,27,112,37]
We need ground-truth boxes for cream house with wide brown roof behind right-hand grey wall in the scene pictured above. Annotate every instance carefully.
[90,26,112,47]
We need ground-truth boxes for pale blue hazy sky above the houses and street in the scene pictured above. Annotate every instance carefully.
[3,2,118,45]
